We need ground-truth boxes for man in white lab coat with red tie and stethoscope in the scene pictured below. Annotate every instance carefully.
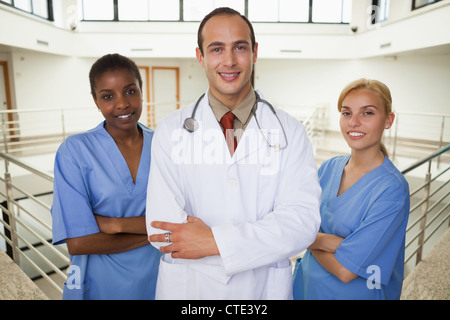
[146,8,321,299]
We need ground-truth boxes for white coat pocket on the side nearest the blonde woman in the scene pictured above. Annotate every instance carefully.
[267,263,292,300]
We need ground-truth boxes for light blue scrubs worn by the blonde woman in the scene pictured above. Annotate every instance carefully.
[294,156,409,300]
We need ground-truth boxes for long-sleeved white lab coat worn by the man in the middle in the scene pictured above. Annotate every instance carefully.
[146,93,321,299]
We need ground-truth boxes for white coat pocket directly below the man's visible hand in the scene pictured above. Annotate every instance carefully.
[155,256,187,300]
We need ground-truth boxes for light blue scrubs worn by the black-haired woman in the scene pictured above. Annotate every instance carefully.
[51,122,161,299]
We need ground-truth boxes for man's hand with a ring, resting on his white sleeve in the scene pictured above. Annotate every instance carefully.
[148,216,220,259]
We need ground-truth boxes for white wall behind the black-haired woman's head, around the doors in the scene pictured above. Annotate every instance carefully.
[12,51,207,109]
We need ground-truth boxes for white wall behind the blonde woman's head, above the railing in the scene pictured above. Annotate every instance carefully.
[255,55,450,130]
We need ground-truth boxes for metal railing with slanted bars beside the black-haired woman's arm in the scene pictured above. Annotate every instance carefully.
[0,152,70,293]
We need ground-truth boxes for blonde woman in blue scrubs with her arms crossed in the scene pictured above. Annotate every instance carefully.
[294,79,409,299]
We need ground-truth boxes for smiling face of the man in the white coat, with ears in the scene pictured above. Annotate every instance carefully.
[196,14,258,108]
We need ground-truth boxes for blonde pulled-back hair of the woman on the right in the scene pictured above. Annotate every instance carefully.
[337,78,392,157]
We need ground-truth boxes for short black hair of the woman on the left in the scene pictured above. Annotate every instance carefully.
[89,53,142,98]
